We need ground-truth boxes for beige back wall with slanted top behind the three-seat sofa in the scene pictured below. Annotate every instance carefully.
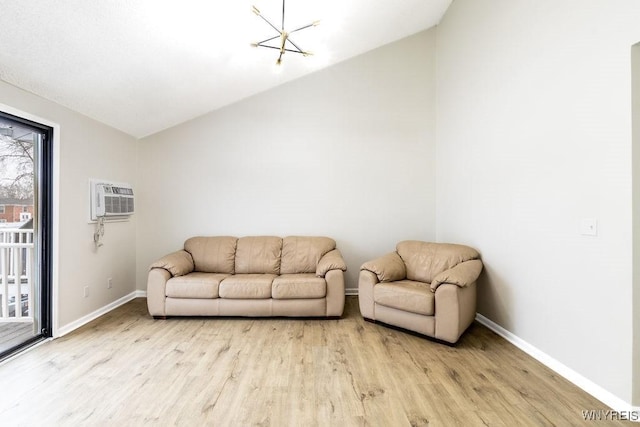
[137,30,435,289]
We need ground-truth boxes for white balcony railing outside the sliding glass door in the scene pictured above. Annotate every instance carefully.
[0,228,34,322]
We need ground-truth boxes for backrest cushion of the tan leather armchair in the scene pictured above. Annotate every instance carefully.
[396,240,479,283]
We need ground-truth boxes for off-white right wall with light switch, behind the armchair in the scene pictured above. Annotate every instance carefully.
[436,0,640,403]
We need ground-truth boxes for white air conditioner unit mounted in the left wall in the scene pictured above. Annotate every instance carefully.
[90,180,135,221]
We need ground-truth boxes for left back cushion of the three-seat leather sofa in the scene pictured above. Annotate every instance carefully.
[184,236,238,274]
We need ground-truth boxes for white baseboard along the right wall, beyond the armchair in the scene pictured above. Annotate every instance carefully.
[476,313,640,420]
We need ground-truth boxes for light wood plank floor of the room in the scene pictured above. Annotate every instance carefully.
[0,297,633,426]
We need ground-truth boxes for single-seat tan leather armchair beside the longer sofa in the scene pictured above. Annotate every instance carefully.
[358,240,482,343]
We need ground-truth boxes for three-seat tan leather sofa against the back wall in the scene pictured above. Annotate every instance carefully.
[147,236,347,318]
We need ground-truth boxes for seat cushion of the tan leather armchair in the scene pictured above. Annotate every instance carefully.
[373,280,435,316]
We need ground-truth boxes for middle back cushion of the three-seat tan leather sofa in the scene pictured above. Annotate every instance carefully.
[235,236,282,274]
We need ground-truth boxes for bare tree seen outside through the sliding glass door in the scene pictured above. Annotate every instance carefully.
[0,127,34,199]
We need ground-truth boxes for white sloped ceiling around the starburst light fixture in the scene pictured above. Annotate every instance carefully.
[0,0,452,137]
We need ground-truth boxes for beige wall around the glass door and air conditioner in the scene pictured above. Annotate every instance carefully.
[0,82,137,329]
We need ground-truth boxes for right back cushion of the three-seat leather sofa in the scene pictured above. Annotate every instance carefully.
[280,236,336,274]
